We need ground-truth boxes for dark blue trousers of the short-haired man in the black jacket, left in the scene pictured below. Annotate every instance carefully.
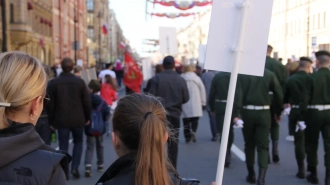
[58,127,84,169]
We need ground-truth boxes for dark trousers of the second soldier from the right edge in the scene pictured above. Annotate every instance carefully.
[289,109,305,164]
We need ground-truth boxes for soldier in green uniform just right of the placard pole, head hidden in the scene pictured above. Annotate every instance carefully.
[234,69,283,185]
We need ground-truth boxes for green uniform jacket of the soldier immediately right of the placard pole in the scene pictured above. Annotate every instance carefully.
[235,69,283,115]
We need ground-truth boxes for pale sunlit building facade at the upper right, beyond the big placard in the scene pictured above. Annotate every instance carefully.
[269,0,330,61]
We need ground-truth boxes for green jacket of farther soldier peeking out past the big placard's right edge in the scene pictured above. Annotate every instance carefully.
[265,56,288,89]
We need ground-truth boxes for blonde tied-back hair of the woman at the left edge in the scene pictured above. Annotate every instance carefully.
[0,51,47,129]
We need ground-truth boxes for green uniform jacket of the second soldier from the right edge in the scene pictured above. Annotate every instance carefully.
[284,71,308,121]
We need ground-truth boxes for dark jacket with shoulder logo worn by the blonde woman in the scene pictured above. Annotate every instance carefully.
[0,122,70,185]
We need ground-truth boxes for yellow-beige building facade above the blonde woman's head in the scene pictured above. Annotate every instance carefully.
[0,0,53,64]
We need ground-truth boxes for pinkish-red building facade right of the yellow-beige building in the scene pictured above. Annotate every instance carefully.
[52,0,87,66]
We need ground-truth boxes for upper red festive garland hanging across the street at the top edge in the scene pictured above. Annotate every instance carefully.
[153,0,212,10]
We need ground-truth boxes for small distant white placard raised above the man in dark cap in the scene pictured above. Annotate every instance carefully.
[159,27,178,56]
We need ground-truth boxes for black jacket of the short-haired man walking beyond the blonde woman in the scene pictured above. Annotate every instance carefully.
[48,73,92,128]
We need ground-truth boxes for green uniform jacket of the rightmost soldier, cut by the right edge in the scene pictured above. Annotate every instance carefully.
[304,68,330,107]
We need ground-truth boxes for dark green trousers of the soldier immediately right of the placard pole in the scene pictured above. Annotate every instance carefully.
[242,109,271,169]
